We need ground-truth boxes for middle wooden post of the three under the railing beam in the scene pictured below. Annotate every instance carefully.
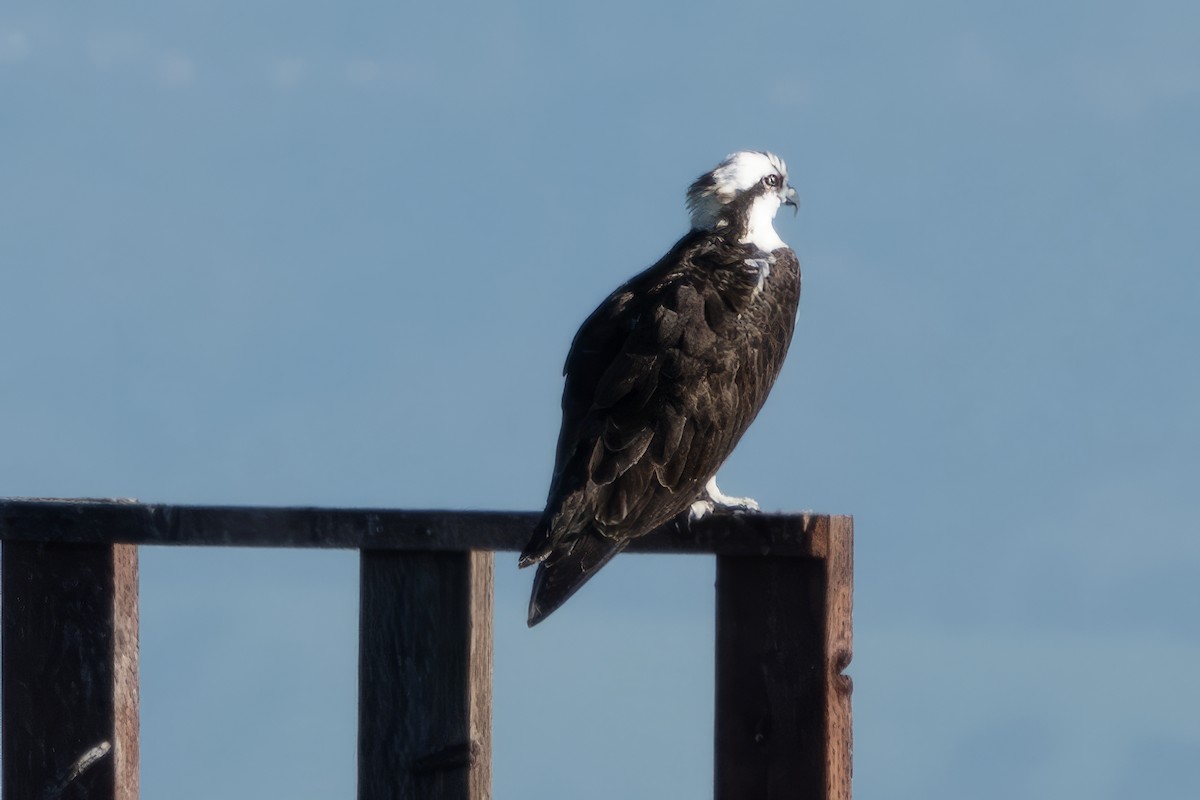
[359,551,494,800]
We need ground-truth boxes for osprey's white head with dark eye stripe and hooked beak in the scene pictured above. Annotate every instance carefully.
[688,150,797,252]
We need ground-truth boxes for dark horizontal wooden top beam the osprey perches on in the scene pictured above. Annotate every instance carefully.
[0,499,844,558]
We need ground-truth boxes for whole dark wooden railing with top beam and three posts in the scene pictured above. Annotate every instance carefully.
[0,499,853,800]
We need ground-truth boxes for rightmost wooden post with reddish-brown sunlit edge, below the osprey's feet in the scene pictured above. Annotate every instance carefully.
[715,517,853,800]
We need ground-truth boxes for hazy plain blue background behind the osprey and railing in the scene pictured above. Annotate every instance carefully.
[0,0,1200,800]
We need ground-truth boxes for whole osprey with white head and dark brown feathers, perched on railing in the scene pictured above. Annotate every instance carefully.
[520,151,800,626]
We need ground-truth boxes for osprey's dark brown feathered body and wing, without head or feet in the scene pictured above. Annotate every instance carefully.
[521,237,794,621]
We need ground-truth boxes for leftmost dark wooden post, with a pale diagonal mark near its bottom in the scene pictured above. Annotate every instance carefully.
[0,542,139,800]
